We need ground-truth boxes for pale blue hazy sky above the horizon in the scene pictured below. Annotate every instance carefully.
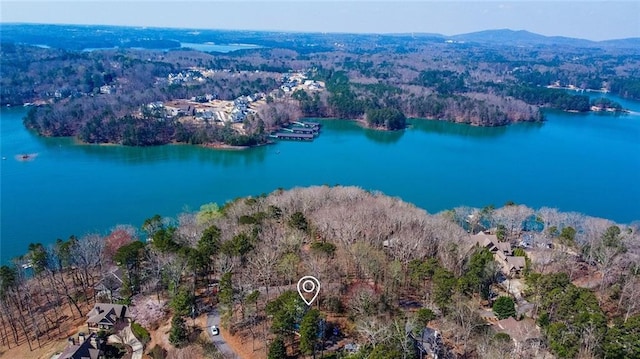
[0,0,640,41]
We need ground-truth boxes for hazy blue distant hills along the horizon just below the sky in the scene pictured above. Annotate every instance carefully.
[0,23,640,50]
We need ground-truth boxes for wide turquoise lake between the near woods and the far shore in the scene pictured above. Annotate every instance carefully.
[0,97,640,263]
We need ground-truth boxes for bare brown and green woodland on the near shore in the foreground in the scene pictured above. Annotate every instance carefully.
[0,186,640,359]
